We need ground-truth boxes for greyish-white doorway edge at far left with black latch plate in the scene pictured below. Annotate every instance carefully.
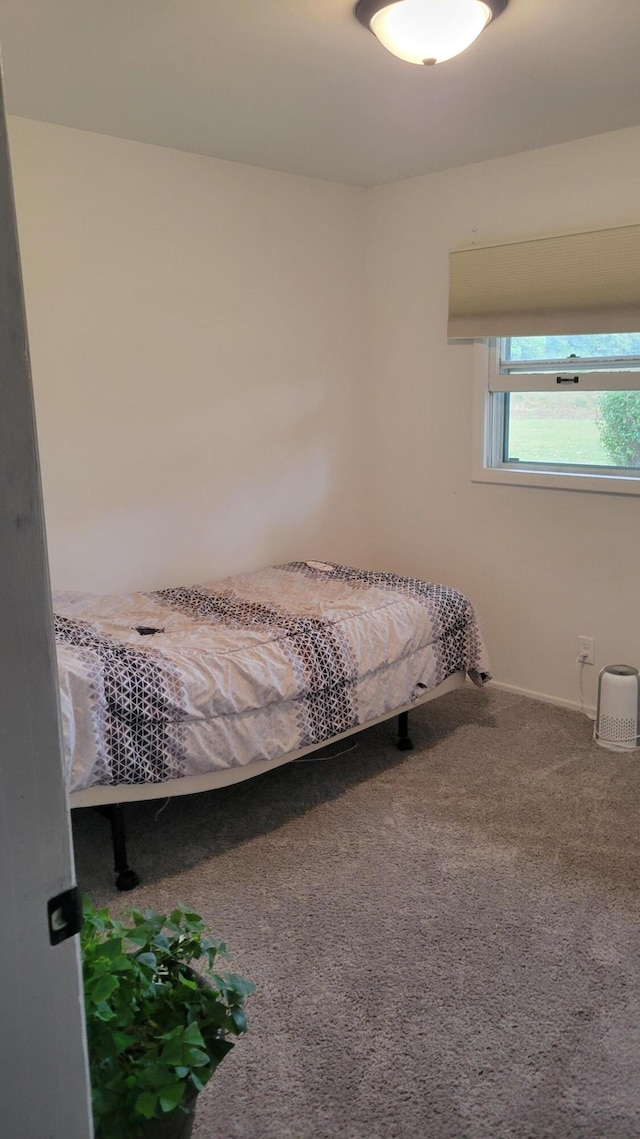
[0,51,92,1139]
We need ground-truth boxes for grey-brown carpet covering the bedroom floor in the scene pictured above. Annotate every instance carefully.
[74,686,640,1139]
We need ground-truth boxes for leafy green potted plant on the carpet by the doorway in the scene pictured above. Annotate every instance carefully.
[81,899,254,1139]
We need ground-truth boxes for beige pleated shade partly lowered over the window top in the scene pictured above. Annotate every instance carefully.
[448,226,640,339]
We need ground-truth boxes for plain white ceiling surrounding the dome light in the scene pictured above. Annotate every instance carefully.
[0,0,640,186]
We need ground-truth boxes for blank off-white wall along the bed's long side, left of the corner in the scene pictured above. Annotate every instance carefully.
[9,118,367,591]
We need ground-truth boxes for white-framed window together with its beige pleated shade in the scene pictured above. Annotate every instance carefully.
[449,224,640,494]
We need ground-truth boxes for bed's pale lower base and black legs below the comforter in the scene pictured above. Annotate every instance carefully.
[68,672,466,890]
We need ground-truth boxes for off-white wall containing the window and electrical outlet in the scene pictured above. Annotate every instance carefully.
[367,128,640,704]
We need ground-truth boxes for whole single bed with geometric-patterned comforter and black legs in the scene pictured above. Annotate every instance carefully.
[54,562,490,890]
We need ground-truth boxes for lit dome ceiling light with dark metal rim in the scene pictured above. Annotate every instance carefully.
[354,0,509,65]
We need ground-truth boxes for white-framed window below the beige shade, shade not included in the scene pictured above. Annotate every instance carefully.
[474,333,640,494]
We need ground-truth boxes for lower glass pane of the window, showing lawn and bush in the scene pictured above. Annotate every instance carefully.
[504,391,640,469]
